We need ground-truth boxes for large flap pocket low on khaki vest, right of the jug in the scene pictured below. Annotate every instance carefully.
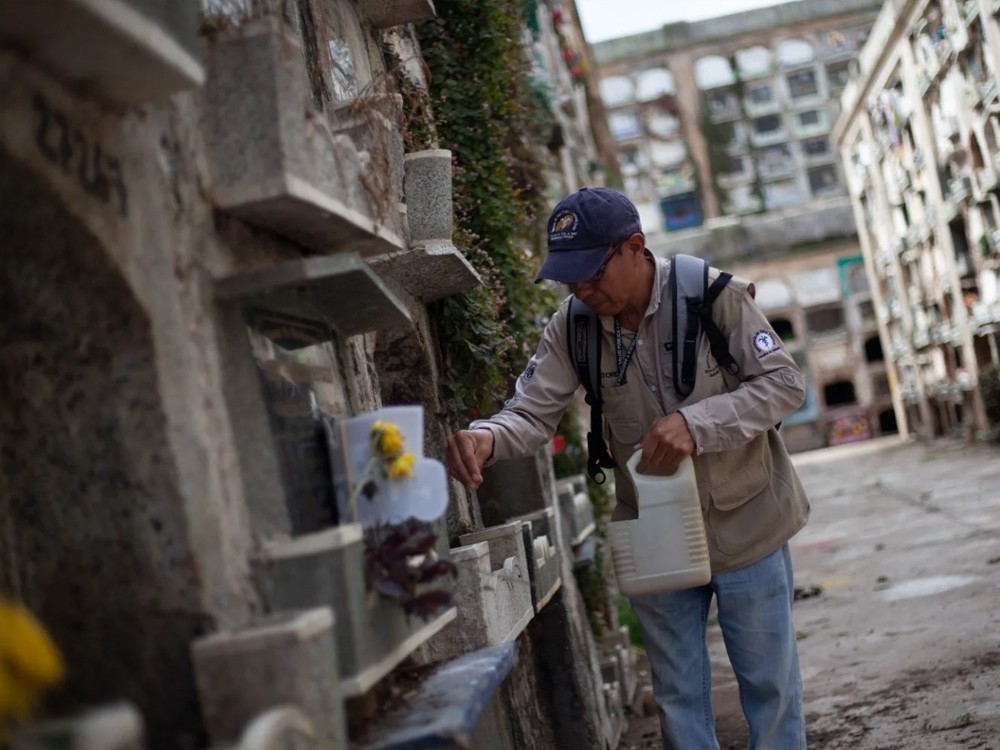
[707,461,782,555]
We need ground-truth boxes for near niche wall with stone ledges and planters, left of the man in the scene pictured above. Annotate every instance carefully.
[0,0,620,750]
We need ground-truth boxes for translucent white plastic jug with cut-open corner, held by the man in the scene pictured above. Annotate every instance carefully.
[607,451,712,596]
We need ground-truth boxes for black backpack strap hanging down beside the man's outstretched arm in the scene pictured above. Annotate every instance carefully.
[566,296,615,484]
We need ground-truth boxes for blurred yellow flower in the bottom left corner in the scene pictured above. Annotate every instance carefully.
[0,599,64,745]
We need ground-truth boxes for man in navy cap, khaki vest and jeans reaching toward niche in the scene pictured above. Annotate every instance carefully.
[448,188,809,750]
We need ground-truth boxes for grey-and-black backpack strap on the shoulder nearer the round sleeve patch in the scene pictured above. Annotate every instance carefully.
[669,253,739,398]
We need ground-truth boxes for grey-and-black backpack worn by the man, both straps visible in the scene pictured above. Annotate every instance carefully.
[566,254,740,484]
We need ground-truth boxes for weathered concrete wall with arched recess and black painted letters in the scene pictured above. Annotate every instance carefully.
[0,55,266,745]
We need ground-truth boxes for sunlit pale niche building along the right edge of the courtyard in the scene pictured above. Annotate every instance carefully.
[835,0,1000,435]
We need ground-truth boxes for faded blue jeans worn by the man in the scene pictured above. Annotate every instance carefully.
[631,544,806,750]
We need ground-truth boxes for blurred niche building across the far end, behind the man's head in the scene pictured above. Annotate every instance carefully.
[594,0,897,449]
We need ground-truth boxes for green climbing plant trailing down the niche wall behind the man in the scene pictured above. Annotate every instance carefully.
[417,0,557,421]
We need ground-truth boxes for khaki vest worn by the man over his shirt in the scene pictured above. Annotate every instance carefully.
[601,269,809,573]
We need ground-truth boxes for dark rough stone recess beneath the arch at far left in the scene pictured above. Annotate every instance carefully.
[0,155,206,746]
